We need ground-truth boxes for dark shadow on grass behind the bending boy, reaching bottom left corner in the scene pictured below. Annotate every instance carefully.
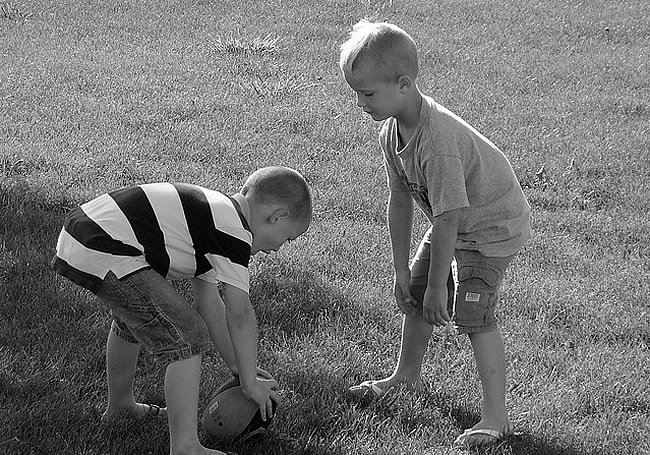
[0,181,168,454]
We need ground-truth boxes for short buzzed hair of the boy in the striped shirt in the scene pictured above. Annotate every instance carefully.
[240,166,312,221]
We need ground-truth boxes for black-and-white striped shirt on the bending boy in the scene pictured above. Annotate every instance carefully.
[52,183,253,292]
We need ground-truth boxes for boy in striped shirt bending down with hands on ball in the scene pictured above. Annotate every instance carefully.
[52,167,311,455]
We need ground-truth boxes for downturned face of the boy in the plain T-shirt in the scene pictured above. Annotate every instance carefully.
[344,64,403,121]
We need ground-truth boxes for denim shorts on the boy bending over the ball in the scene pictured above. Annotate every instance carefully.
[96,268,212,362]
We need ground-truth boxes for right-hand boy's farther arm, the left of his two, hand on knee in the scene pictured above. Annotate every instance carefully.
[388,191,417,314]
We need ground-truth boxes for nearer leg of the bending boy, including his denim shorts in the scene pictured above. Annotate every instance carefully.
[98,270,222,455]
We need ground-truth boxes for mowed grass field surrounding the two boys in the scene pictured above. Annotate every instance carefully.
[0,0,650,455]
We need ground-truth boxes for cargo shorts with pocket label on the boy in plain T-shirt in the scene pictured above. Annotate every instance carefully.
[410,229,516,333]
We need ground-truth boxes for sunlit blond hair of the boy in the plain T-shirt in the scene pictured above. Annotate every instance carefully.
[339,20,419,81]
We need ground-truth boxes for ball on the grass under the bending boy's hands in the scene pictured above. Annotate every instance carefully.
[201,379,277,441]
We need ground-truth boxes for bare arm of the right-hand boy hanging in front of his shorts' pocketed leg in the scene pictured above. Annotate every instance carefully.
[422,210,458,326]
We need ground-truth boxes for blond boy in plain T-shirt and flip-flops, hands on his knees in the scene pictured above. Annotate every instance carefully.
[340,21,530,446]
